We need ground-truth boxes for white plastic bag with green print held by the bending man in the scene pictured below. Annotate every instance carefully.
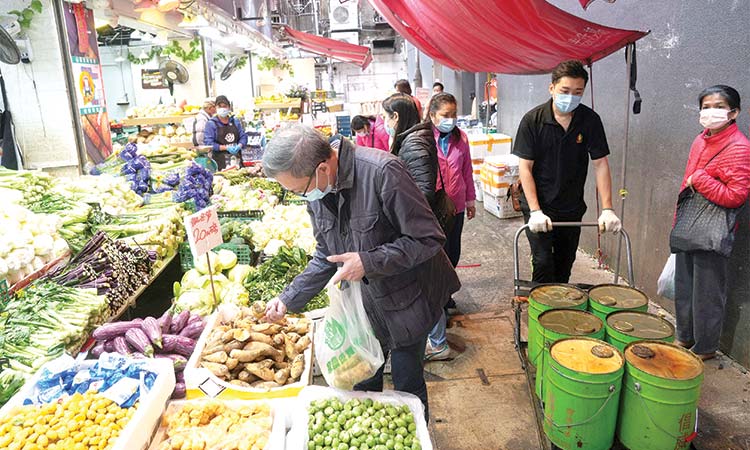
[315,282,384,390]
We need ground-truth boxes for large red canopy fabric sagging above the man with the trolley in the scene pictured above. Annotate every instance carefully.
[370,0,648,74]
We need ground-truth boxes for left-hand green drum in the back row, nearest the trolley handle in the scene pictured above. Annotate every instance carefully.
[528,284,589,366]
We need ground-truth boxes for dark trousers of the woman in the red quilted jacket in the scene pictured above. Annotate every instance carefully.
[674,252,729,354]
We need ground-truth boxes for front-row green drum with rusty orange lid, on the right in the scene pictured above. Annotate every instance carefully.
[617,341,703,450]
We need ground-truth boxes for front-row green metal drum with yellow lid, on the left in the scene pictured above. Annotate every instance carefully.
[544,338,624,450]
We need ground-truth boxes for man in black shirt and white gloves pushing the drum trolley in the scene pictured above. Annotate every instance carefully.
[513,61,621,283]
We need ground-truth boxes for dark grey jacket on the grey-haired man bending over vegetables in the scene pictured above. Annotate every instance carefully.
[280,140,461,349]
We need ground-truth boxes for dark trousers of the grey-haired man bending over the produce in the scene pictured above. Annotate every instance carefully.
[354,336,430,420]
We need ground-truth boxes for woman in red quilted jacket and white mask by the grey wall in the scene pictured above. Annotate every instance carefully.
[675,85,750,360]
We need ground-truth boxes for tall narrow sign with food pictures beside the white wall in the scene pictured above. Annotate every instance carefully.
[63,3,112,164]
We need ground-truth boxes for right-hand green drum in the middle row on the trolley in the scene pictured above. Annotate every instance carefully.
[606,311,674,351]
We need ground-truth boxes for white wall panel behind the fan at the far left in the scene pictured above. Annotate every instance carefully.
[0,0,78,168]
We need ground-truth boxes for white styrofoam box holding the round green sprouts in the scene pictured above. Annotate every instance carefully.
[286,386,433,450]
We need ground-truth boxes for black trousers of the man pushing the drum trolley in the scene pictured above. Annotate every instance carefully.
[523,209,582,283]
